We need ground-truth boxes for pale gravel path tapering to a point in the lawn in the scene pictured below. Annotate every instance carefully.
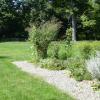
[13,61,100,100]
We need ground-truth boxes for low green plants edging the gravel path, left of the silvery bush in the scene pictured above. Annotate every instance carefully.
[39,58,92,81]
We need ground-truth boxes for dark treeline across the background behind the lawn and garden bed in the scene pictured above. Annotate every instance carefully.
[0,0,100,40]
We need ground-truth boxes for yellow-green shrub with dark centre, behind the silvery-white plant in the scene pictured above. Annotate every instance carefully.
[72,42,96,59]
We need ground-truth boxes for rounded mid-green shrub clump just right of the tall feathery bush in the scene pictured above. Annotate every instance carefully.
[47,42,72,60]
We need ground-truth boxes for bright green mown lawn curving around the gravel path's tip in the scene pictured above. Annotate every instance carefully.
[0,42,73,100]
